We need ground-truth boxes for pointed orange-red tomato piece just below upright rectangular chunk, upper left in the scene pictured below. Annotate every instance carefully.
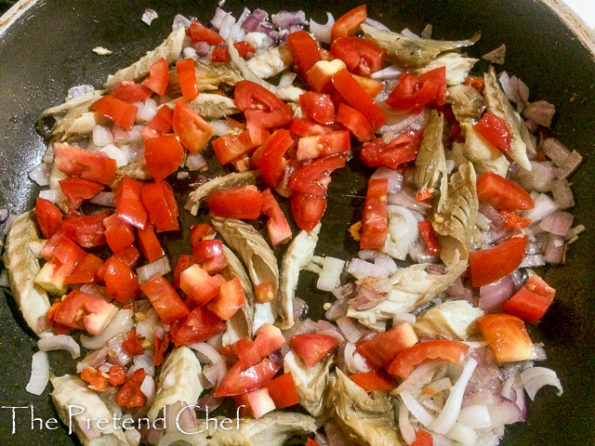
[172,99,214,153]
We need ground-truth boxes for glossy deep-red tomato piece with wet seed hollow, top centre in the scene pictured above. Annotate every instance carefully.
[233,81,293,129]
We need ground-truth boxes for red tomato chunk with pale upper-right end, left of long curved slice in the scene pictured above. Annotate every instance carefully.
[356,322,418,369]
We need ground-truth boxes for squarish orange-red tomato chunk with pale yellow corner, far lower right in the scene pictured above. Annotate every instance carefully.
[476,314,535,363]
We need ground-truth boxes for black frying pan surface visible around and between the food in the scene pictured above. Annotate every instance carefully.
[0,0,595,446]
